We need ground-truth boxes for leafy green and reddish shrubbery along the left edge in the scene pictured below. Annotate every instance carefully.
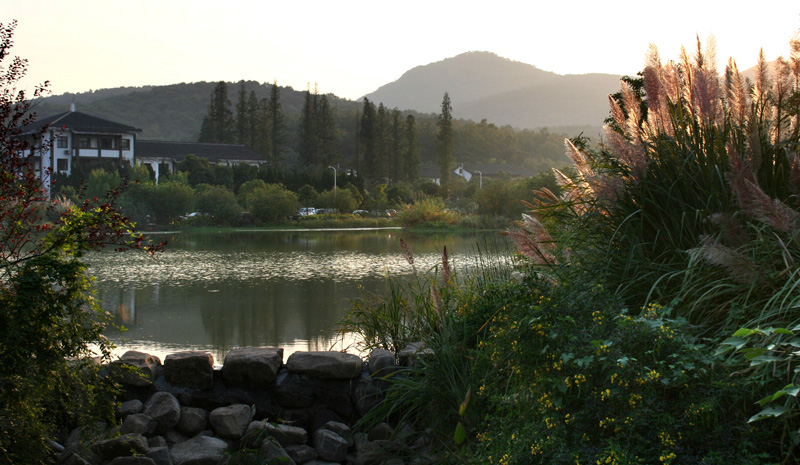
[0,22,159,463]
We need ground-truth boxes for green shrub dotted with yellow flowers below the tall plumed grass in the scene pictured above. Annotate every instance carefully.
[472,283,774,464]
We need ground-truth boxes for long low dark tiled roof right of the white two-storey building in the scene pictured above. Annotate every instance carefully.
[136,140,266,162]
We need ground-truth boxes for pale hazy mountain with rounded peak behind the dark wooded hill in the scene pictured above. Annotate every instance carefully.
[366,52,620,128]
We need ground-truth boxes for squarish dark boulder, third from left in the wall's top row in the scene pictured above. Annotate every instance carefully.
[221,347,283,388]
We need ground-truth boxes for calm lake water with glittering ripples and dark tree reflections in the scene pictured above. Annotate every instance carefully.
[87,229,507,364]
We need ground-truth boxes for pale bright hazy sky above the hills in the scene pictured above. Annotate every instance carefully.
[6,0,800,99]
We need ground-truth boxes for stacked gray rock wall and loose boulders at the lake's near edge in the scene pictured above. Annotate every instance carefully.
[59,347,434,465]
